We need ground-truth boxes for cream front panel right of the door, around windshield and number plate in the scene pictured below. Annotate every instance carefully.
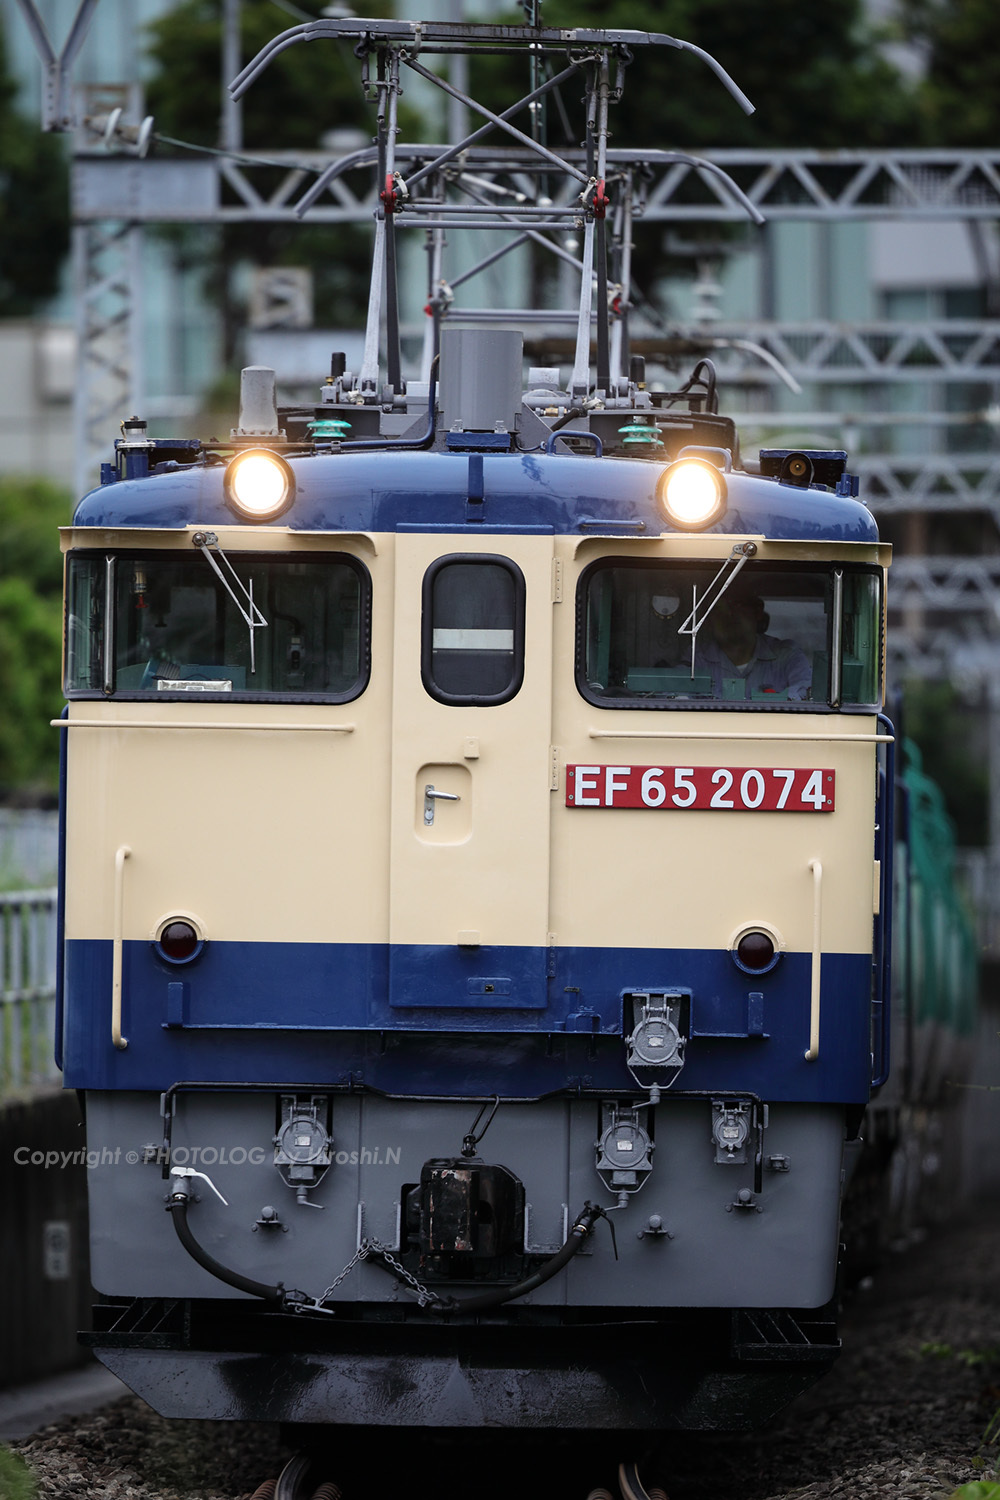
[552,537,885,953]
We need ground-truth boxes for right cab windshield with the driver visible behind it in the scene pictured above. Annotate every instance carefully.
[577,560,882,708]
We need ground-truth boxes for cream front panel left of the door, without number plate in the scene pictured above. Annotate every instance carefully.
[58,533,393,942]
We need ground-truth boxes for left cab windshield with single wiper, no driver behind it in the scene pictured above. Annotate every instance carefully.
[66,552,369,699]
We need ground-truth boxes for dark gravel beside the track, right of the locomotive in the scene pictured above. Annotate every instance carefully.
[669,1214,1000,1500]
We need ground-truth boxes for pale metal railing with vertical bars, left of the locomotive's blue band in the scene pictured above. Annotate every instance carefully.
[0,888,58,1097]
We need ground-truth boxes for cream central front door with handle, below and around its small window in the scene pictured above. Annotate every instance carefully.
[390,533,552,947]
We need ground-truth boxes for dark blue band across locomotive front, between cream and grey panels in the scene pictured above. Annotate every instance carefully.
[64,939,871,1103]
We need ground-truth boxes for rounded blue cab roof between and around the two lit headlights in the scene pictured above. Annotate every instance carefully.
[73,452,879,542]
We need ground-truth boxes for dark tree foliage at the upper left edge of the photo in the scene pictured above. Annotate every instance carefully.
[0,29,69,318]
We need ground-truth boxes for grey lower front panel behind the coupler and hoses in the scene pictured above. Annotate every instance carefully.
[87,1092,844,1308]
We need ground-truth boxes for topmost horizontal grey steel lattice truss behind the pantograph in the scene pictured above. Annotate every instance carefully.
[73,138,1000,225]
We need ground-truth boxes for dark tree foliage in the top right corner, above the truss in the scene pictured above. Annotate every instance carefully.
[904,0,1000,147]
